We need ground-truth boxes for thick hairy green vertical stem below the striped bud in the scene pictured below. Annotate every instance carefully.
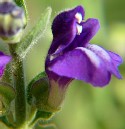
[9,44,26,127]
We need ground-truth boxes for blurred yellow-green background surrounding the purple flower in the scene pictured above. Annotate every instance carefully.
[1,0,125,129]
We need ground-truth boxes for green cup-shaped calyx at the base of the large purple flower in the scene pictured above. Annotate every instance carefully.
[27,73,62,113]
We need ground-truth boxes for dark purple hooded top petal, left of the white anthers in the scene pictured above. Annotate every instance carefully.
[48,6,84,54]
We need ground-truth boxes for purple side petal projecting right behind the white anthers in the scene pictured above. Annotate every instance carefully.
[65,18,100,51]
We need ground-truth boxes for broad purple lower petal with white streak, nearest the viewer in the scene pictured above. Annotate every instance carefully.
[48,47,111,86]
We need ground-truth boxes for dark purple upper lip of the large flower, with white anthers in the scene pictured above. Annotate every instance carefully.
[48,6,100,55]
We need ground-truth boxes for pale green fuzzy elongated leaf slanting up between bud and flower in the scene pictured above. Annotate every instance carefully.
[16,7,52,58]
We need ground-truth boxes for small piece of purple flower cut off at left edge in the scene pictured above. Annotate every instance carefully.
[0,51,11,78]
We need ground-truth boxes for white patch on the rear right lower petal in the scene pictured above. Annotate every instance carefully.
[87,44,111,61]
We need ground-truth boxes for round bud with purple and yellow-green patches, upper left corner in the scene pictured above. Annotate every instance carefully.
[0,0,26,43]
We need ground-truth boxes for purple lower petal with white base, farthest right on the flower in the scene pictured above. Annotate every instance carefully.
[87,44,122,79]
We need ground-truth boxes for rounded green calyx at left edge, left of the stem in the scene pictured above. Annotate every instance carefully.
[0,82,15,116]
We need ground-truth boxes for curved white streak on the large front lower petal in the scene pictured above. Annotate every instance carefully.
[76,47,101,67]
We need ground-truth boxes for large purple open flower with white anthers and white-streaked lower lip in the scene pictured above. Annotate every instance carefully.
[45,6,122,87]
